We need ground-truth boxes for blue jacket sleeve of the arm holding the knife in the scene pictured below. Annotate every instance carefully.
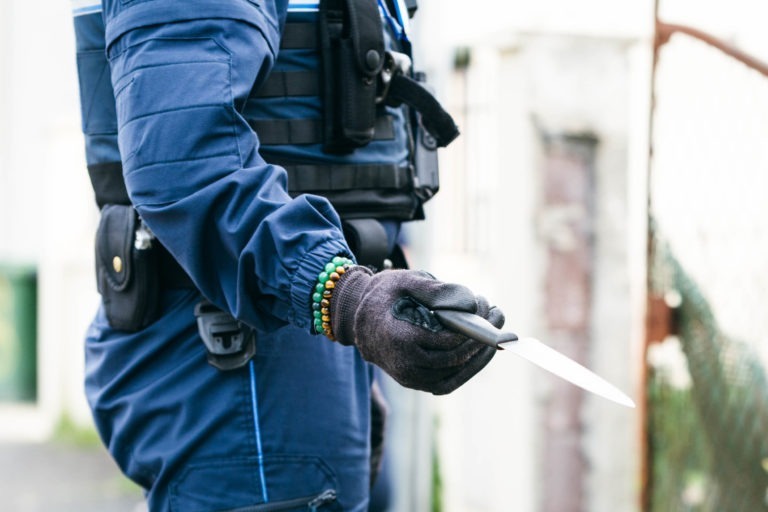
[104,0,349,330]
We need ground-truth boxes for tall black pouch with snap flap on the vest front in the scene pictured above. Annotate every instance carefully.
[318,0,384,153]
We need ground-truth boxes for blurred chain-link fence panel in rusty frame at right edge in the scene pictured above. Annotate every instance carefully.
[645,7,768,512]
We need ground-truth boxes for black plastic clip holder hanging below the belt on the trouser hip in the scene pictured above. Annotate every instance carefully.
[195,300,256,371]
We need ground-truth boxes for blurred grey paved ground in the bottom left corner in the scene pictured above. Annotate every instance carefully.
[0,442,146,512]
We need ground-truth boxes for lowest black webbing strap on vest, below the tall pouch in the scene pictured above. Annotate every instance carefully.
[283,164,413,194]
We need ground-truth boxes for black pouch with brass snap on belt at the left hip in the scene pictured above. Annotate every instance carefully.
[96,204,159,332]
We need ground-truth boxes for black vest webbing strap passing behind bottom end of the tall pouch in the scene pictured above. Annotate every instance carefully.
[248,116,395,145]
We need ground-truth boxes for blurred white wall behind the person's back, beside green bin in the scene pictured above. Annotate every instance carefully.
[0,0,97,438]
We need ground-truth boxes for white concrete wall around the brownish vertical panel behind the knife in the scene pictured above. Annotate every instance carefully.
[416,0,652,512]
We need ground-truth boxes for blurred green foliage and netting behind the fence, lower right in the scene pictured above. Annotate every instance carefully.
[648,240,768,512]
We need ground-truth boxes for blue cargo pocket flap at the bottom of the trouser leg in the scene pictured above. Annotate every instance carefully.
[170,456,341,512]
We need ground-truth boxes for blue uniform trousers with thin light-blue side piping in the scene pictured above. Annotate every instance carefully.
[86,290,371,512]
